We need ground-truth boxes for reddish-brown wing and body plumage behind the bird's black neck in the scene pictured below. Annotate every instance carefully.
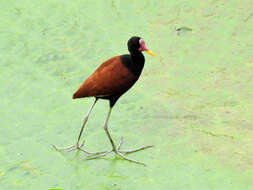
[73,56,138,98]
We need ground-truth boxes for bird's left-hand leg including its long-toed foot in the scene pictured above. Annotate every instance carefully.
[53,98,105,155]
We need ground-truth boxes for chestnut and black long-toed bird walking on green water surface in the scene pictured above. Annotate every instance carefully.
[53,36,154,165]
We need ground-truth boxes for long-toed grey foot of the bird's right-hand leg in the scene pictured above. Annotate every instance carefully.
[88,137,153,166]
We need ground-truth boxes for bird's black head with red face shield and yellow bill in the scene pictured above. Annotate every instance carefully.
[127,36,154,56]
